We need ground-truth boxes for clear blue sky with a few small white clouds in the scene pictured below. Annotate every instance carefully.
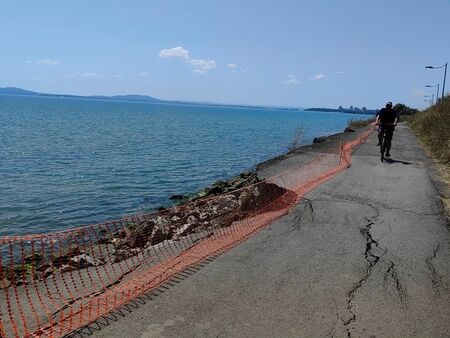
[0,0,450,108]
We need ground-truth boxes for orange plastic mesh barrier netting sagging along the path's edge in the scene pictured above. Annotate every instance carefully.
[0,130,371,337]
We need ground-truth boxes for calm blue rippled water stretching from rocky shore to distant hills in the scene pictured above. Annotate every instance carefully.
[0,95,367,236]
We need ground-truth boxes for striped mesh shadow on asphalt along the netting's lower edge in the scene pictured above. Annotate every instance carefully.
[65,254,220,338]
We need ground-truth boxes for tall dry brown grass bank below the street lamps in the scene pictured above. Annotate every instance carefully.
[408,96,450,167]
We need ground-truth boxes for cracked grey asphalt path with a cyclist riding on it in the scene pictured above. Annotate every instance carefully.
[89,125,450,338]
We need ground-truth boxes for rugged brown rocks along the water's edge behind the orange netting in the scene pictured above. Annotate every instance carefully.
[0,125,368,289]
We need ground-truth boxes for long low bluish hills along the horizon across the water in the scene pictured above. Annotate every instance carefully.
[0,87,375,114]
